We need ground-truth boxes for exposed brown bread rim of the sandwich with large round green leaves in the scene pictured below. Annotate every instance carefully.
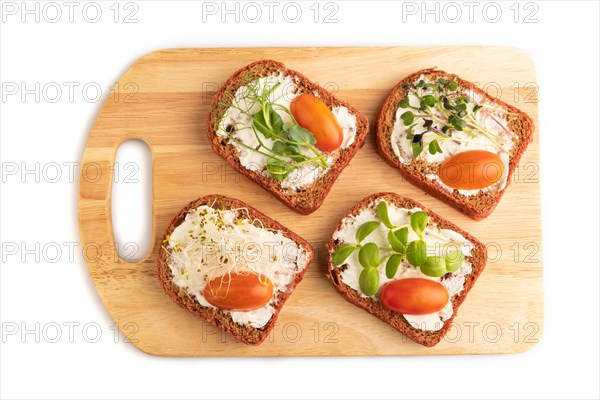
[327,192,487,347]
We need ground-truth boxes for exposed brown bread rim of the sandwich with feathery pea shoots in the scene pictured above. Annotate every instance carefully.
[207,60,369,214]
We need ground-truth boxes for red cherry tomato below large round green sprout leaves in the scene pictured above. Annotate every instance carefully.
[381,278,450,315]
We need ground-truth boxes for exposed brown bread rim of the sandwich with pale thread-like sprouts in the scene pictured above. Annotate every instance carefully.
[157,194,314,345]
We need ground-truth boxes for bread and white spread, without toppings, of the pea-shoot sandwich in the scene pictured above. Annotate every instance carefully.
[207,60,369,214]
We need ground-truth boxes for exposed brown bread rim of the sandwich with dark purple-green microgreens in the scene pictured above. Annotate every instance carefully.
[377,68,534,220]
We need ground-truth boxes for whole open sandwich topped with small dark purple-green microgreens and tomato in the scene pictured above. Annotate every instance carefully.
[377,69,534,220]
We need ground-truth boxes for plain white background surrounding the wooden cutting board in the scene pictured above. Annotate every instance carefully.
[0,1,600,398]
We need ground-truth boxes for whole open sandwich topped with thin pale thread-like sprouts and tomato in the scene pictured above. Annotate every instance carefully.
[157,195,313,345]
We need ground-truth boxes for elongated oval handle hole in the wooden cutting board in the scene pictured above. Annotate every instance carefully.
[111,140,152,262]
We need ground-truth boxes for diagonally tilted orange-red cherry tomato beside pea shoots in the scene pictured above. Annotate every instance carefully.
[290,93,344,151]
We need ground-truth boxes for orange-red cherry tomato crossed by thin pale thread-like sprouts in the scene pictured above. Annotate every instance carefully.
[204,273,273,311]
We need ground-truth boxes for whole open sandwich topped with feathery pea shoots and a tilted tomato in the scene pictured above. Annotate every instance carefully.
[207,60,369,214]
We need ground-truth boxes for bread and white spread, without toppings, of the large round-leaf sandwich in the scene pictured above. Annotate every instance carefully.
[327,193,487,347]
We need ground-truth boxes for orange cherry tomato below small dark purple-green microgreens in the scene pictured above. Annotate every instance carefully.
[439,150,504,190]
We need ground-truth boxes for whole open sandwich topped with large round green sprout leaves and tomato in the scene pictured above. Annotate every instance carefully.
[327,193,487,347]
